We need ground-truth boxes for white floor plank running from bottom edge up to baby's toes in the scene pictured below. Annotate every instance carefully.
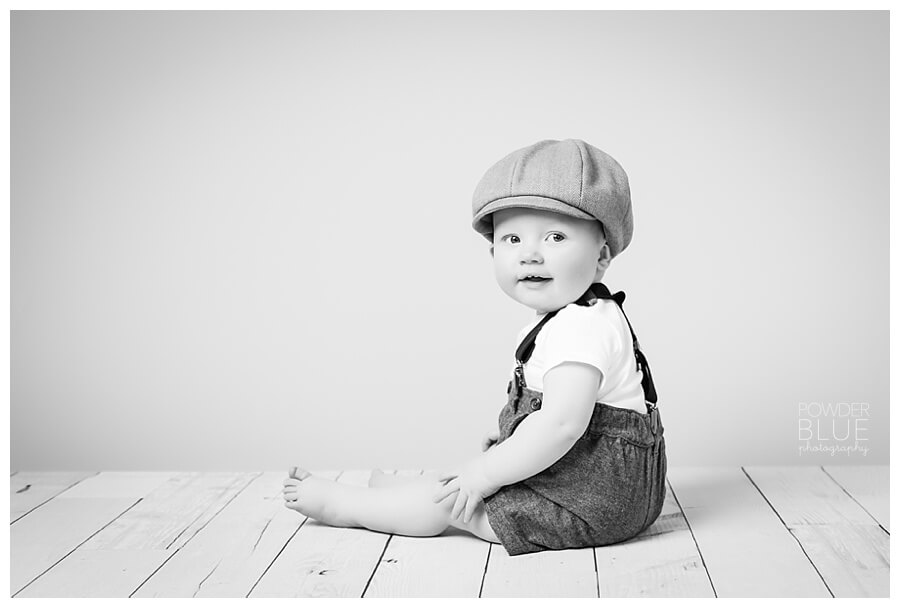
[132,471,310,597]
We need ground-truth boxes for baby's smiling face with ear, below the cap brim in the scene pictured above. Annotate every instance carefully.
[493,207,610,313]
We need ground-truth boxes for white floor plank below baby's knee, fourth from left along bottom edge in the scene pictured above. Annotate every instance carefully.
[365,470,490,597]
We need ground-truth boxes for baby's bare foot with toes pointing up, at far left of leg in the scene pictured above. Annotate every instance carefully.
[284,467,357,528]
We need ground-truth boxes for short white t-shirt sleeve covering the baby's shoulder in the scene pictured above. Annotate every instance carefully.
[543,304,622,377]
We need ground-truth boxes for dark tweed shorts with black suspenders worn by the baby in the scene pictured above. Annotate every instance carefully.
[484,283,666,555]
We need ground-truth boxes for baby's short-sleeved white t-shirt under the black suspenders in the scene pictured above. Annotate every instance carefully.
[511,299,647,413]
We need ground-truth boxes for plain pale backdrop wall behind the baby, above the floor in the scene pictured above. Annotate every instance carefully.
[10,11,889,470]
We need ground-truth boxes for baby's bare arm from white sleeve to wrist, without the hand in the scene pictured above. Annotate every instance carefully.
[481,361,603,486]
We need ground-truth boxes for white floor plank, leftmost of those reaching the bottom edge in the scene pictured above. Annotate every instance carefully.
[20,473,258,597]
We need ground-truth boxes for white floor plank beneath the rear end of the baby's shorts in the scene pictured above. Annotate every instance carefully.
[594,480,715,597]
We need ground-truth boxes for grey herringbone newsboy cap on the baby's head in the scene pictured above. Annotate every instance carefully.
[472,139,634,257]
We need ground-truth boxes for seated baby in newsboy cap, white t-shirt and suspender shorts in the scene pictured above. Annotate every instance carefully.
[284,139,666,555]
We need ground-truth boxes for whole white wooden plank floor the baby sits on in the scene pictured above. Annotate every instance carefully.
[10,466,890,597]
